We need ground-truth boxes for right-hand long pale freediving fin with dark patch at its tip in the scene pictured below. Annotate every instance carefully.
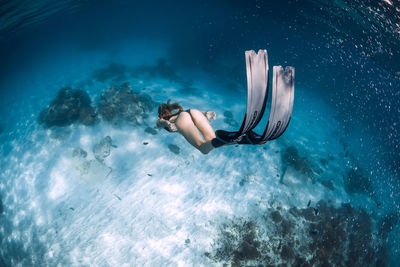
[243,66,294,144]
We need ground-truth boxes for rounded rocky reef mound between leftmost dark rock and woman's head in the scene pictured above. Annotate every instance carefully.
[97,83,155,126]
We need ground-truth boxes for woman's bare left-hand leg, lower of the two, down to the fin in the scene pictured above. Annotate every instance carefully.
[175,112,214,154]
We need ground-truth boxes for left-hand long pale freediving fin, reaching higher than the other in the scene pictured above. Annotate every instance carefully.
[213,49,269,147]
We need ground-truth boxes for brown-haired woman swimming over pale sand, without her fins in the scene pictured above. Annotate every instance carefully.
[157,100,216,154]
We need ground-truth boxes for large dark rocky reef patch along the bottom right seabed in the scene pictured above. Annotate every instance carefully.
[205,200,387,266]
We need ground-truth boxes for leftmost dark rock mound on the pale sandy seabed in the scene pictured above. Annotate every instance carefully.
[38,87,97,127]
